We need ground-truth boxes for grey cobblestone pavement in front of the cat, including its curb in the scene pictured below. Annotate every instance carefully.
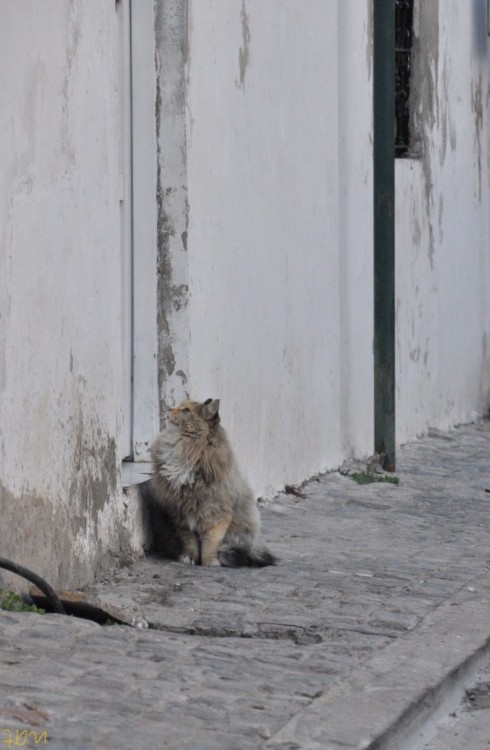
[0,422,490,750]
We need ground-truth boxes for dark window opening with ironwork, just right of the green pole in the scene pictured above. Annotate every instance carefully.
[395,0,414,157]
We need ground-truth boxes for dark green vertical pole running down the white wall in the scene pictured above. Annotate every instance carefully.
[373,0,396,471]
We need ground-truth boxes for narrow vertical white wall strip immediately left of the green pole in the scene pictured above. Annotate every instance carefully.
[338,0,374,458]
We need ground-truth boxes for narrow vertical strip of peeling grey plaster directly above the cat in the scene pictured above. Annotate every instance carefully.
[155,0,189,420]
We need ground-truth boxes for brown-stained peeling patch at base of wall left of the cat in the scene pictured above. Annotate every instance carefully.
[0,425,121,586]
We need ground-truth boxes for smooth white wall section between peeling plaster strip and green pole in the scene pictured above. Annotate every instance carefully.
[182,0,372,494]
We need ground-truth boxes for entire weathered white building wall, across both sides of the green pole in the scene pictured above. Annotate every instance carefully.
[0,0,490,585]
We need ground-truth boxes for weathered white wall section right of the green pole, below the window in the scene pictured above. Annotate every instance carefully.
[396,0,490,442]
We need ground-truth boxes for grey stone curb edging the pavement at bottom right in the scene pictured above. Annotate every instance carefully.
[263,579,490,750]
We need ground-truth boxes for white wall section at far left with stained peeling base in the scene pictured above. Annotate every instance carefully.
[0,0,142,585]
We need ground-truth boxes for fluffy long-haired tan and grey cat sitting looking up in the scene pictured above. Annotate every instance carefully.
[151,399,276,567]
